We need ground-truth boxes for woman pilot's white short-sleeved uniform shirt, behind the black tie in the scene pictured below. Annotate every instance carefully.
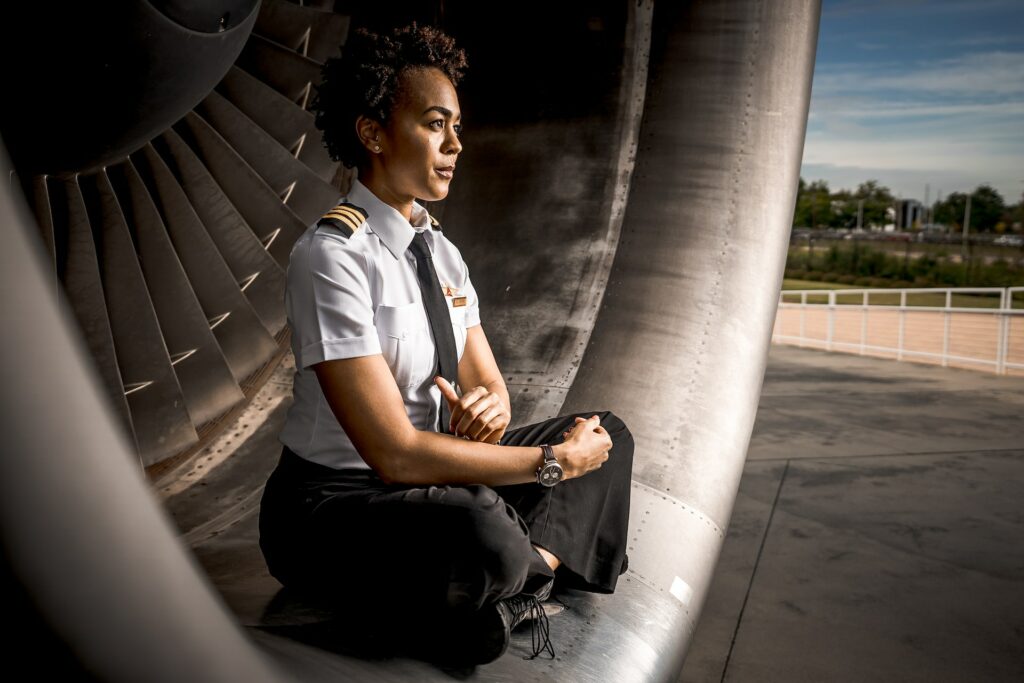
[280,180,480,470]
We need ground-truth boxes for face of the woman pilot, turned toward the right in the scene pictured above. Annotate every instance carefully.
[370,68,462,202]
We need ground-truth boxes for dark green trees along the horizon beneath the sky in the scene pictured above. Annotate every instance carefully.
[793,178,1024,233]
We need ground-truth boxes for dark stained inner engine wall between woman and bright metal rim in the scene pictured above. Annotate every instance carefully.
[438,2,653,425]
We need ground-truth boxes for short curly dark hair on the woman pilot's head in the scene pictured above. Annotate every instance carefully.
[310,22,466,168]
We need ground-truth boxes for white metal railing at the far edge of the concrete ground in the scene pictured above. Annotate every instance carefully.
[772,287,1024,375]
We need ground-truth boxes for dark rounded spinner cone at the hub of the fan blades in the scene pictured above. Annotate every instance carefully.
[0,0,260,177]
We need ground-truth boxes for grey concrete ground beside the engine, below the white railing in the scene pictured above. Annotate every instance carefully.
[679,346,1024,683]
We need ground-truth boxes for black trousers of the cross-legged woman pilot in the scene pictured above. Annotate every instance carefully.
[259,412,633,610]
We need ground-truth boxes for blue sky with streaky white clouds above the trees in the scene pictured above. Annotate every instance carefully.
[801,0,1024,203]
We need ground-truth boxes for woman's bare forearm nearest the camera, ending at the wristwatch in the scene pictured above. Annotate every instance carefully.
[380,431,544,486]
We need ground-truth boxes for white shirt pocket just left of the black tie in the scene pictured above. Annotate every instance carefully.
[375,301,434,387]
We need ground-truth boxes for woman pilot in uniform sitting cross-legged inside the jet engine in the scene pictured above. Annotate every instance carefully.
[259,24,633,664]
